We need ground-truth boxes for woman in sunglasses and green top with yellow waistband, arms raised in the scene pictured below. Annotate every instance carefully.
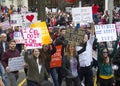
[97,39,119,86]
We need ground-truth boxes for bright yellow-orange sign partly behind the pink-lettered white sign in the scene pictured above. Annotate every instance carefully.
[30,22,52,44]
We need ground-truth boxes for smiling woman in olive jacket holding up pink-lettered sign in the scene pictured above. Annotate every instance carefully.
[24,49,50,86]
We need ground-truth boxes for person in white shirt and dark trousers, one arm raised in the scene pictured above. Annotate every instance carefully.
[76,24,95,86]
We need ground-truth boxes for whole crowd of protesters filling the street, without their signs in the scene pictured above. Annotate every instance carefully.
[0,4,120,86]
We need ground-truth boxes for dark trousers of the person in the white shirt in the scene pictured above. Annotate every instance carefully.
[79,66,94,86]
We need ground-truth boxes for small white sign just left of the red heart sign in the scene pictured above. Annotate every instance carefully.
[10,14,22,26]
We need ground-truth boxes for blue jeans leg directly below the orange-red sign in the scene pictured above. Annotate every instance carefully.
[50,68,59,86]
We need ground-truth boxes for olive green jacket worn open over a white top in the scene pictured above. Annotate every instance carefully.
[24,52,49,85]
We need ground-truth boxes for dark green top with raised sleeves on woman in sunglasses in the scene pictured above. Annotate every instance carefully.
[97,39,119,76]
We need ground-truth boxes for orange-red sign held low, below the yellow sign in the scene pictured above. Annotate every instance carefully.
[50,45,62,68]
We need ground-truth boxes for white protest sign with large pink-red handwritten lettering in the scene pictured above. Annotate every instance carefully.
[23,28,42,49]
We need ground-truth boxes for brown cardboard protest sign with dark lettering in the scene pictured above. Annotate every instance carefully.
[65,29,85,45]
